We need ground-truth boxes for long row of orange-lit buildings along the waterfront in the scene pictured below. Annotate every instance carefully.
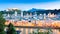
[5,21,60,27]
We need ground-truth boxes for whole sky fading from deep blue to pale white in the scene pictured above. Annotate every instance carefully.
[0,0,60,10]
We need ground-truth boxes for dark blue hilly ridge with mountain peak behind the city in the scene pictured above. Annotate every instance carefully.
[0,8,60,14]
